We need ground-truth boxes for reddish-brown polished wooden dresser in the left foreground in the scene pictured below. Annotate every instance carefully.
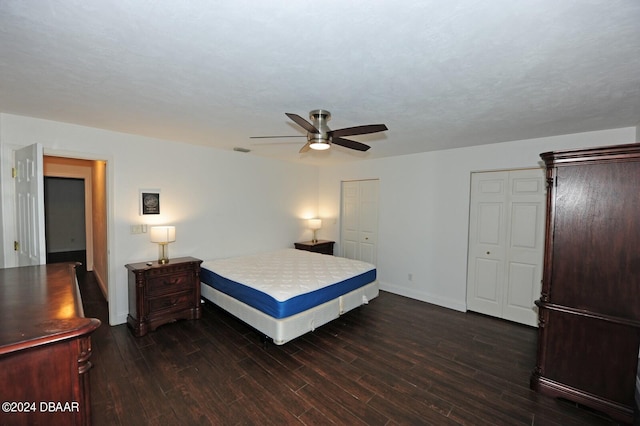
[0,264,100,425]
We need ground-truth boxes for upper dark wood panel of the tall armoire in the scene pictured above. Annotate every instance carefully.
[551,162,640,317]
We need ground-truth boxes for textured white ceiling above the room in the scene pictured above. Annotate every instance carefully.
[0,0,640,164]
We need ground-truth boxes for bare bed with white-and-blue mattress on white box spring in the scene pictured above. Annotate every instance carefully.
[200,249,378,345]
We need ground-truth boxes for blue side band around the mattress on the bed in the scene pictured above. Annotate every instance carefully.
[200,253,376,319]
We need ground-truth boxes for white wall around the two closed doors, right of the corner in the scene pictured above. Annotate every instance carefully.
[319,127,636,311]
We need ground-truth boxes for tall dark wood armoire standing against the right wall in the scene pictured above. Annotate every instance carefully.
[531,143,640,423]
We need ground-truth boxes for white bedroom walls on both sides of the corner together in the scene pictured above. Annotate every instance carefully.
[0,114,636,324]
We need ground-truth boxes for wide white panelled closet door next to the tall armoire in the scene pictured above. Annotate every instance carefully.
[467,169,546,326]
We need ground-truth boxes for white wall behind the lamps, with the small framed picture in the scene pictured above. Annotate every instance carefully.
[0,114,318,325]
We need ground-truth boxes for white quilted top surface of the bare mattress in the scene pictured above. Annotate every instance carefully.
[202,249,375,302]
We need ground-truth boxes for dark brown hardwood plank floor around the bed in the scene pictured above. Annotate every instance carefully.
[79,273,628,426]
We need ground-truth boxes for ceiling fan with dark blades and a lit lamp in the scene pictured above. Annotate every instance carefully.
[251,109,388,153]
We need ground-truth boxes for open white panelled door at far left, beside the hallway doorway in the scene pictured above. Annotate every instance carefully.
[15,144,46,266]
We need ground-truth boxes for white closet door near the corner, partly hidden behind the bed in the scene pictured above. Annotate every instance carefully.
[341,179,378,265]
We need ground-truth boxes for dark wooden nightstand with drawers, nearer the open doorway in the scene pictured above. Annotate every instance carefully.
[126,257,202,337]
